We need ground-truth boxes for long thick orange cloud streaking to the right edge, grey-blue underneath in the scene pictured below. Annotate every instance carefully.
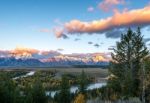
[55,6,150,38]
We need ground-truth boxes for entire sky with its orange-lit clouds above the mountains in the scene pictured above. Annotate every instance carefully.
[0,0,150,54]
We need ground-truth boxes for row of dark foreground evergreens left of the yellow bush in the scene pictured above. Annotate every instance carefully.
[0,71,88,103]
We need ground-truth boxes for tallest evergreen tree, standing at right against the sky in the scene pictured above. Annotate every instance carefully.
[108,28,148,97]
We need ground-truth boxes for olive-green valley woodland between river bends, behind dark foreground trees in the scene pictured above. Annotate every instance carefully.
[5,70,95,91]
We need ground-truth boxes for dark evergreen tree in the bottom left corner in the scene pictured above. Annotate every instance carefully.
[0,74,21,103]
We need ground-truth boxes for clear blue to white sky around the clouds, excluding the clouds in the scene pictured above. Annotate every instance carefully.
[0,0,150,53]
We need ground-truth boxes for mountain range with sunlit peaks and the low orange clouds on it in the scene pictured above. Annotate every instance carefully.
[0,47,110,66]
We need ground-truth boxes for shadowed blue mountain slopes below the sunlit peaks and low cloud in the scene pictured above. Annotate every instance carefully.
[0,57,109,67]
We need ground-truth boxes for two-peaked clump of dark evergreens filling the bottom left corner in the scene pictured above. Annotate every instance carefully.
[0,74,48,103]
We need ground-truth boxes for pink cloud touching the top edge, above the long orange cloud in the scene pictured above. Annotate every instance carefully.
[98,0,125,11]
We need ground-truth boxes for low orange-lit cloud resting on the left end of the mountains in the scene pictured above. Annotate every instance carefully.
[0,46,60,59]
